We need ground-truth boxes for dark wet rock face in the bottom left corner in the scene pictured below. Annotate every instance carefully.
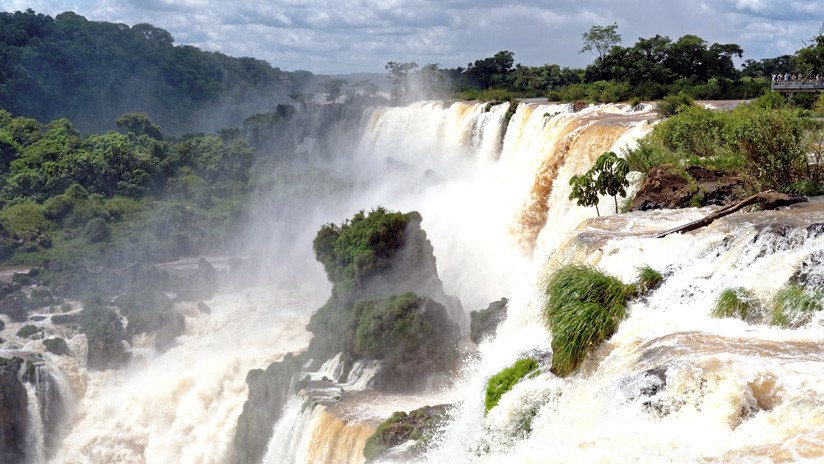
[0,358,28,463]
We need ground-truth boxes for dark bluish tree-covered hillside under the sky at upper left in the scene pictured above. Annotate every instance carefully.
[0,10,312,134]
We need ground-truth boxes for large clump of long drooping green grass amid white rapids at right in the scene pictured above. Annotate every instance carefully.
[543,264,638,377]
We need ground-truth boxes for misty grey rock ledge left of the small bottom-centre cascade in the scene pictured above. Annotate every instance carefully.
[234,354,304,464]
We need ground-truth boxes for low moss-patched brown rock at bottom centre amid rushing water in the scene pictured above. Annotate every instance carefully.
[363,404,449,462]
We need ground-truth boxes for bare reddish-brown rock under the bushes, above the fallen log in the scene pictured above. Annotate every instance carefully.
[630,165,745,211]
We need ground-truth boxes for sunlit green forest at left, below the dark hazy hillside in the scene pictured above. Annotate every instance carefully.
[0,110,255,264]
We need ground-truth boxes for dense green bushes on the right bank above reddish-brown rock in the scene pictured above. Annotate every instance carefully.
[626,100,824,194]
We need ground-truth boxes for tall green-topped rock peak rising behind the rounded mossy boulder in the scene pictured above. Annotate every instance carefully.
[307,208,465,359]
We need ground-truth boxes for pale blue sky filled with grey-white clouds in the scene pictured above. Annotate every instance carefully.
[0,0,824,74]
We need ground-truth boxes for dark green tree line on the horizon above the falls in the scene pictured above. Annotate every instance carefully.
[386,24,824,106]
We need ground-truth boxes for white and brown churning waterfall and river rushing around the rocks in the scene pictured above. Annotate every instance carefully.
[12,102,824,464]
